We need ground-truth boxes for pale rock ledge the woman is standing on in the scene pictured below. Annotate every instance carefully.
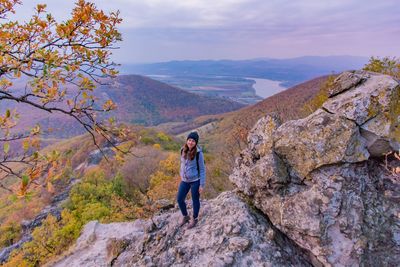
[54,192,311,266]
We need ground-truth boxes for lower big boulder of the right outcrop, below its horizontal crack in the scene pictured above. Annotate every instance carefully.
[253,162,400,266]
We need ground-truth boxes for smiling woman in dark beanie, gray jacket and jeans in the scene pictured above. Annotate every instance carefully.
[177,132,206,228]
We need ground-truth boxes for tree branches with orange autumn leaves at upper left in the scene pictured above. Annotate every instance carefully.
[0,0,122,194]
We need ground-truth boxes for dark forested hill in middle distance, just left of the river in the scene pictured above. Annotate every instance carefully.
[98,75,244,126]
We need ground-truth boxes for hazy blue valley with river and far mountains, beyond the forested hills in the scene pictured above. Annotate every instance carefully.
[121,56,367,105]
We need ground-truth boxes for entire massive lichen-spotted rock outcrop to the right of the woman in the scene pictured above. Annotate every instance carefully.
[230,72,400,266]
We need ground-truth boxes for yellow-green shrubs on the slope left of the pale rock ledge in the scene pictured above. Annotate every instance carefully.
[2,169,140,266]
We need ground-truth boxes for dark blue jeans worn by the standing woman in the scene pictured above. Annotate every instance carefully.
[177,180,200,219]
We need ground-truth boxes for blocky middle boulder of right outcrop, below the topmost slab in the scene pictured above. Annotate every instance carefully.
[273,109,369,178]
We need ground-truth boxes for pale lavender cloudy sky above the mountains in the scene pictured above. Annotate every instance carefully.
[9,0,400,64]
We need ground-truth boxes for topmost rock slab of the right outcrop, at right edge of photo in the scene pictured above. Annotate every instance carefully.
[323,72,400,156]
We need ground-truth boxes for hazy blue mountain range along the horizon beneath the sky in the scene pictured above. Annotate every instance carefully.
[121,56,368,87]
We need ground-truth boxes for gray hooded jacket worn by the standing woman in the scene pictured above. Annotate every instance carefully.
[180,146,206,187]
